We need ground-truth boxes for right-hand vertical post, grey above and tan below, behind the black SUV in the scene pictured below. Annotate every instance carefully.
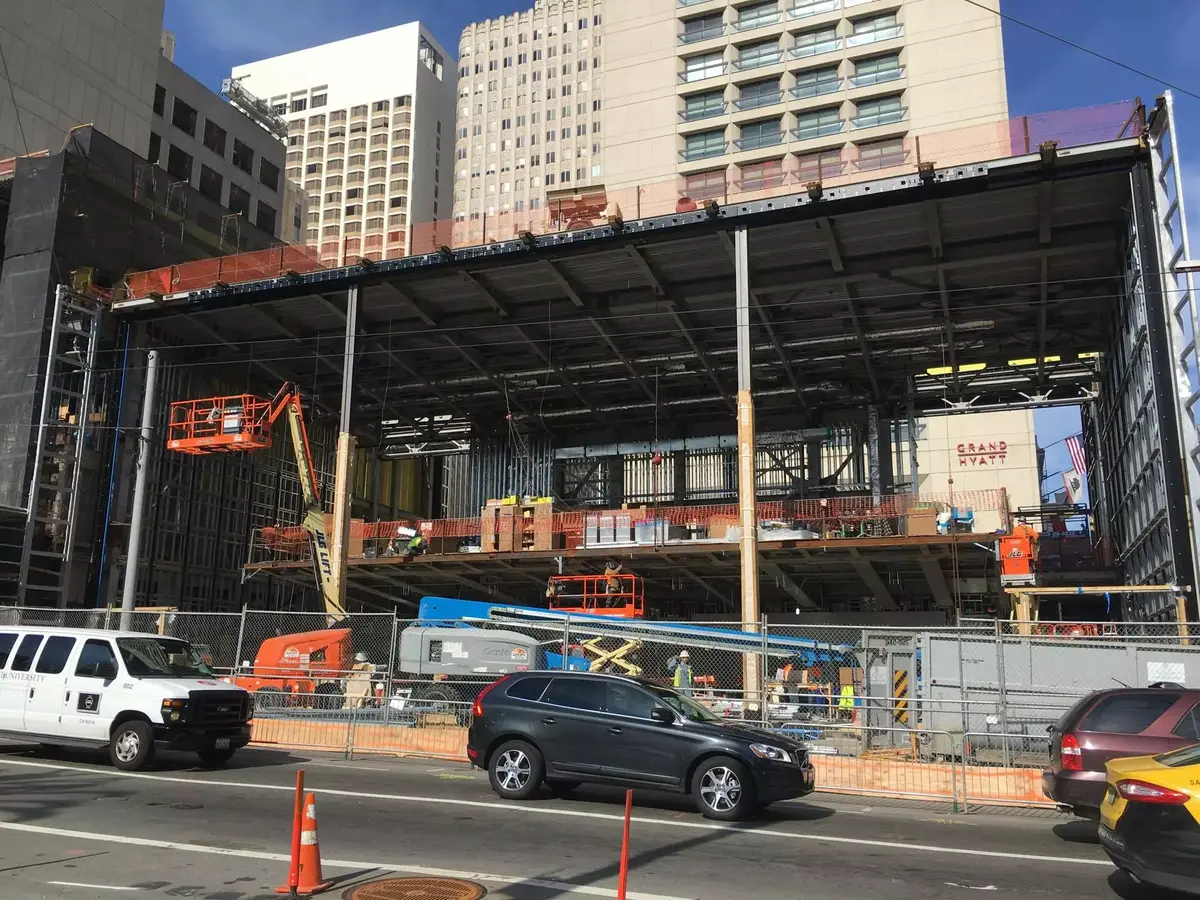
[733,226,762,709]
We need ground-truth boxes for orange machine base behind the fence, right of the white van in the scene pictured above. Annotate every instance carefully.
[233,628,354,708]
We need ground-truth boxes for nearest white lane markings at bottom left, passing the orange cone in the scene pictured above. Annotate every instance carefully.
[0,822,691,900]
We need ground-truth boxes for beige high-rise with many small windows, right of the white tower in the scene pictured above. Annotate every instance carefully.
[454,0,604,242]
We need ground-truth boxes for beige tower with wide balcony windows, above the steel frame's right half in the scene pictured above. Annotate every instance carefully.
[602,0,1009,210]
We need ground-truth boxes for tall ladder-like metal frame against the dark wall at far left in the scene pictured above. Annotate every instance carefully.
[17,284,100,607]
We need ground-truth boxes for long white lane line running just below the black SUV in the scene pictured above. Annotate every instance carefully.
[0,760,1112,868]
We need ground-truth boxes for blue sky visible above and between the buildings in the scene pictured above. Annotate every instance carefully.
[166,0,1200,501]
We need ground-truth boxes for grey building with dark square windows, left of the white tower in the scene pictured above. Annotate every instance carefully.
[154,56,295,241]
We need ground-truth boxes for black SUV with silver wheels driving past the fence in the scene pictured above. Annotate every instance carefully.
[467,672,814,820]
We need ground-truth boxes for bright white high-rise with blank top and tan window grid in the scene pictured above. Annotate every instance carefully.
[233,22,454,264]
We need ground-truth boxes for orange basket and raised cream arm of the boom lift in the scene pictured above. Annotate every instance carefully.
[167,382,346,625]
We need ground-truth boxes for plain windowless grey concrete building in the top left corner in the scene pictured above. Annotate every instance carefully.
[0,0,163,157]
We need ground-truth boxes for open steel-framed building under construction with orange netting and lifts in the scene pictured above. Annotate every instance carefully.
[0,96,1200,628]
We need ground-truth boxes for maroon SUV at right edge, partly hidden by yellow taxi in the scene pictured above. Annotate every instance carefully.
[1042,685,1200,818]
